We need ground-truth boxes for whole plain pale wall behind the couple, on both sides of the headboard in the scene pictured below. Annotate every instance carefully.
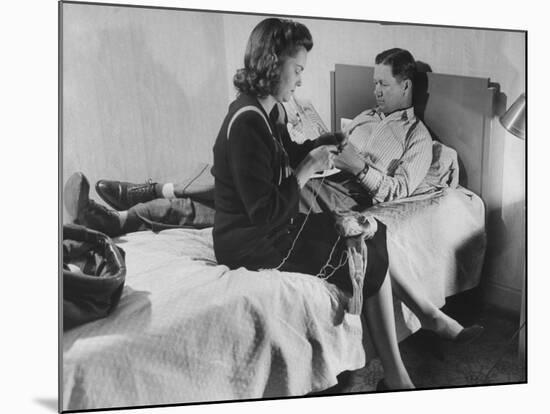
[63,4,526,310]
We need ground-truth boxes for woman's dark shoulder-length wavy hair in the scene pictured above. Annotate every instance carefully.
[233,18,313,98]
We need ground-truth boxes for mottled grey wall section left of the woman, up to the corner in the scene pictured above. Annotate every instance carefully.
[62,4,228,202]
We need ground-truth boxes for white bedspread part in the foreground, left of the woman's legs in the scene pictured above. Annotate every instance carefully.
[63,229,365,409]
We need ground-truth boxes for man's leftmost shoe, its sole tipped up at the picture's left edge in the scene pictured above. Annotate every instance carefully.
[63,172,122,237]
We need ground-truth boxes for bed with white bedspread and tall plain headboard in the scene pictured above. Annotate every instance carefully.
[61,65,494,410]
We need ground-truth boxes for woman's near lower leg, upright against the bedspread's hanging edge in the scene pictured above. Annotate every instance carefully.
[365,275,414,389]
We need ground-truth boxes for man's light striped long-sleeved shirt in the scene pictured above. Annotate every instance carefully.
[346,107,432,203]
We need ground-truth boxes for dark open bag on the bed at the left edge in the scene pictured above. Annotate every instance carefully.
[63,224,126,331]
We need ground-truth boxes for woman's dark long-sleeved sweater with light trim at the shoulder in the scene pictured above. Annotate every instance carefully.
[212,94,314,269]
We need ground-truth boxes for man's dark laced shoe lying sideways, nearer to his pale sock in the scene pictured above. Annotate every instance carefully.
[95,180,158,211]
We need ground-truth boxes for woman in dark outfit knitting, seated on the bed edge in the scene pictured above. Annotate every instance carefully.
[213,18,414,389]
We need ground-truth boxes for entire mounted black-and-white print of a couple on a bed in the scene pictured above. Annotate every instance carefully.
[59,1,527,411]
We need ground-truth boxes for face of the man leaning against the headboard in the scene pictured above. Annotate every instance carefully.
[374,64,408,114]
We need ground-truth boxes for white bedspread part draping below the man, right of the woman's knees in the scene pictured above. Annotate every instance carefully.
[366,187,487,352]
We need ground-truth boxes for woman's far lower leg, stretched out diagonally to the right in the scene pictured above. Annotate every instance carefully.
[390,269,464,339]
